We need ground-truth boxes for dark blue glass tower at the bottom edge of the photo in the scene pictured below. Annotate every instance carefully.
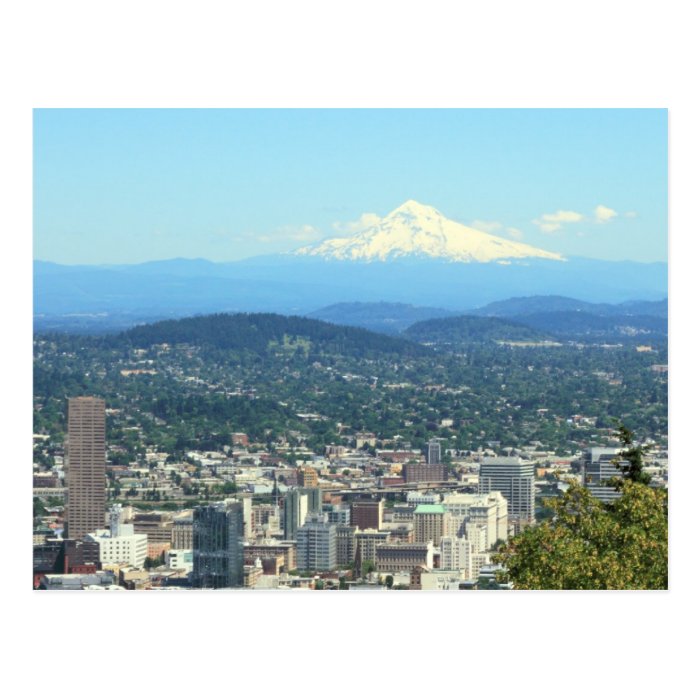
[192,499,244,588]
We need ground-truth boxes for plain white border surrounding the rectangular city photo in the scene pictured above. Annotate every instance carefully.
[0,0,700,698]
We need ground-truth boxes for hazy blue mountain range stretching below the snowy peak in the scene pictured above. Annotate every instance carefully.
[34,255,668,320]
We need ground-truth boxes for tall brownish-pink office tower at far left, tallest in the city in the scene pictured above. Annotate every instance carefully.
[66,396,105,540]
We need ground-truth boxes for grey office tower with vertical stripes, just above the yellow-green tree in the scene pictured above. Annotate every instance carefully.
[479,457,535,530]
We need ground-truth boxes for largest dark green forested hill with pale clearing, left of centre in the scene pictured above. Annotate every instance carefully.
[110,314,426,357]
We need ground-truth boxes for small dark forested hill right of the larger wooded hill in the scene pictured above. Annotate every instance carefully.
[404,316,552,343]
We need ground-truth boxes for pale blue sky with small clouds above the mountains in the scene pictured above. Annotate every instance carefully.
[34,109,668,264]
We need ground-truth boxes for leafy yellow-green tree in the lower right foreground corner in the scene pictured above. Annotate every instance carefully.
[494,478,668,590]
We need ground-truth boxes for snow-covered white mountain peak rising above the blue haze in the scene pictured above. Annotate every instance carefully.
[295,199,564,263]
